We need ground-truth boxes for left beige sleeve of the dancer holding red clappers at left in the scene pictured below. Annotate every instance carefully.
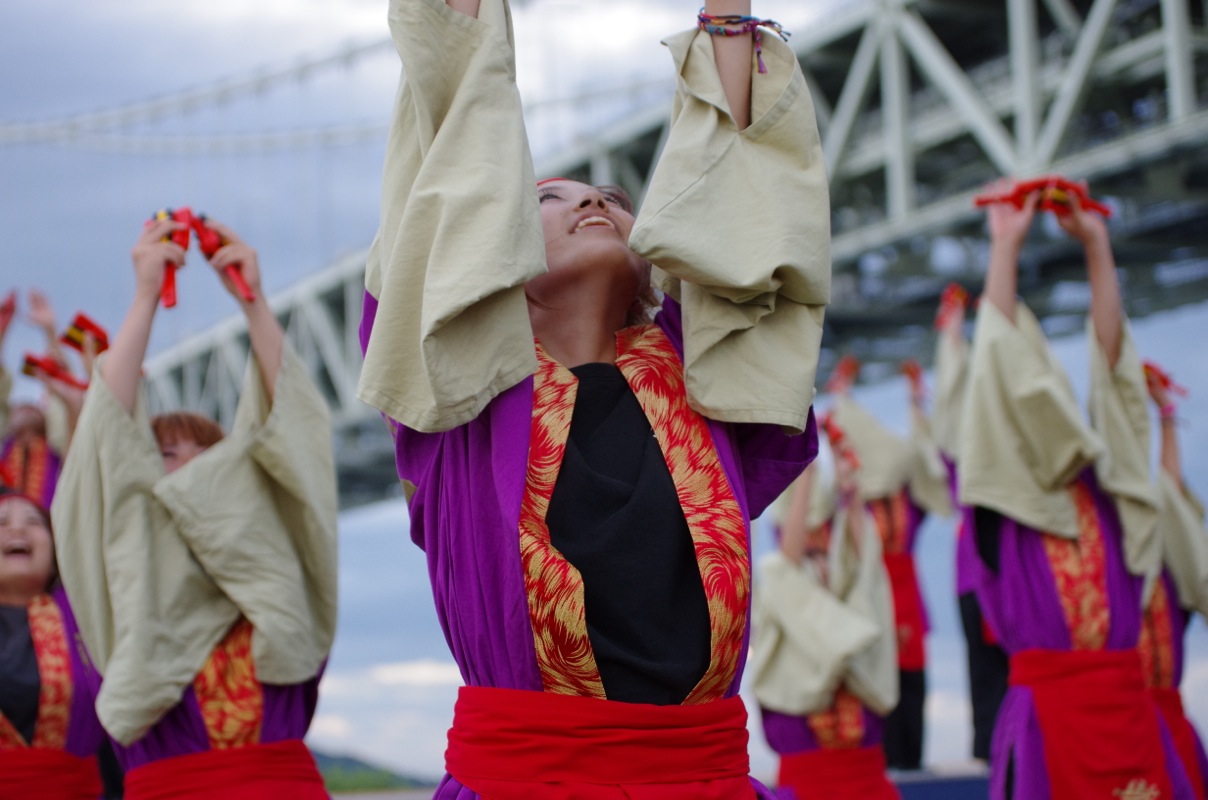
[51,356,239,744]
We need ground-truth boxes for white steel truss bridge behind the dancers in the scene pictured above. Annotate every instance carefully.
[147,0,1208,502]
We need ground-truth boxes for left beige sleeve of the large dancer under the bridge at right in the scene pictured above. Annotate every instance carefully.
[957,302,1103,538]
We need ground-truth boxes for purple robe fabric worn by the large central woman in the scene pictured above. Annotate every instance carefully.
[360,292,818,800]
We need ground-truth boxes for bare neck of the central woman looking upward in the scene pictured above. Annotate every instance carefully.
[529,275,632,367]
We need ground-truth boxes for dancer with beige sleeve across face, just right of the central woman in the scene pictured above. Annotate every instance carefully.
[751,435,899,800]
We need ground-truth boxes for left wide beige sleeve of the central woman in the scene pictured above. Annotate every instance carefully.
[358,0,545,431]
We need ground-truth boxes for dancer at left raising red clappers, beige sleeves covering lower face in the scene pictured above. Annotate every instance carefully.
[53,220,336,800]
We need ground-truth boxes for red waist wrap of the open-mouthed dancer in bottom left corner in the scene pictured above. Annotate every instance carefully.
[0,747,101,800]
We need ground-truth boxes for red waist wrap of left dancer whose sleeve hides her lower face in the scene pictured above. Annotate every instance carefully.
[126,738,329,800]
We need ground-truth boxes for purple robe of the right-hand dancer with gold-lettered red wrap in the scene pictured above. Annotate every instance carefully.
[963,469,1192,800]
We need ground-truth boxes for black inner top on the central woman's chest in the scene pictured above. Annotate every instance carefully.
[546,364,710,706]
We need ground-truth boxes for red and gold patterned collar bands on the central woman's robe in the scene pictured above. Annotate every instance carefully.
[519,325,750,705]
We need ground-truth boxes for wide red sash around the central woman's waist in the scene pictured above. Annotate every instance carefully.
[445,686,755,800]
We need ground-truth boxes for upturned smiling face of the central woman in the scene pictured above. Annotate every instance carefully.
[530,179,649,305]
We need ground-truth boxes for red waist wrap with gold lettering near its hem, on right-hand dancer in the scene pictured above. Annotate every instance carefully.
[1010,650,1172,799]
